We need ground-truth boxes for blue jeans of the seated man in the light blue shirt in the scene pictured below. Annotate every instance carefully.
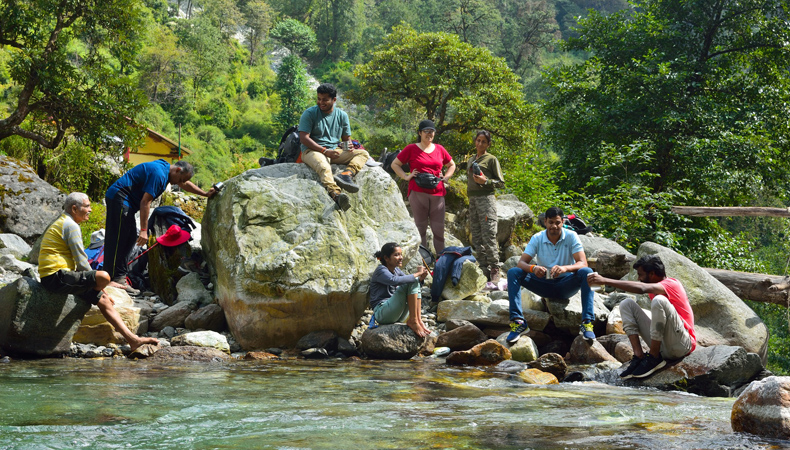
[507,267,595,322]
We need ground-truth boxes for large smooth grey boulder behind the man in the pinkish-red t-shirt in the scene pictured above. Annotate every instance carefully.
[627,242,768,362]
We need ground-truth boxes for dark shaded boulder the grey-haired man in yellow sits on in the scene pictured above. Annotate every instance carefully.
[0,277,91,357]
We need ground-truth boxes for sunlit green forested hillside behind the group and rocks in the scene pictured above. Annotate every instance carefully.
[0,0,790,374]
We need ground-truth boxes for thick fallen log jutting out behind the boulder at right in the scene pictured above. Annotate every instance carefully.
[705,268,790,307]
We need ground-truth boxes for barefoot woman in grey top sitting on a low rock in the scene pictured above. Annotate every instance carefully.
[370,242,431,337]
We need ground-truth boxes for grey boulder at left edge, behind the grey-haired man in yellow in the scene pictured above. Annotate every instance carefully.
[0,155,65,243]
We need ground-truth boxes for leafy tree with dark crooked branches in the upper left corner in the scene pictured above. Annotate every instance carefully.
[0,0,145,148]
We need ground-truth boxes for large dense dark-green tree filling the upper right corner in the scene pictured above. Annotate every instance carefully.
[546,0,790,205]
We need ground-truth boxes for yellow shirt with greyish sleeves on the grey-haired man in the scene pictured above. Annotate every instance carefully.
[38,213,92,277]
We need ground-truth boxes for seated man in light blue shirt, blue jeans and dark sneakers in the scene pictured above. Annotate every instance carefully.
[507,206,595,344]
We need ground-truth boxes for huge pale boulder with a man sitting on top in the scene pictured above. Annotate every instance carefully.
[201,164,419,350]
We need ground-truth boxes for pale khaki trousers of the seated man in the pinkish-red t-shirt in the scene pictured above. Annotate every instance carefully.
[620,295,691,359]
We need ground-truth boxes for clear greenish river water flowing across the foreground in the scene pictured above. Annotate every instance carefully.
[0,359,790,450]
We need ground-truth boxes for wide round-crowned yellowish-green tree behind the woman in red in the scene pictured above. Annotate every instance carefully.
[352,25,535,145]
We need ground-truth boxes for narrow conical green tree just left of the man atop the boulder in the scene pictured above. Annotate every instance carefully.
[274,55,312,130]
